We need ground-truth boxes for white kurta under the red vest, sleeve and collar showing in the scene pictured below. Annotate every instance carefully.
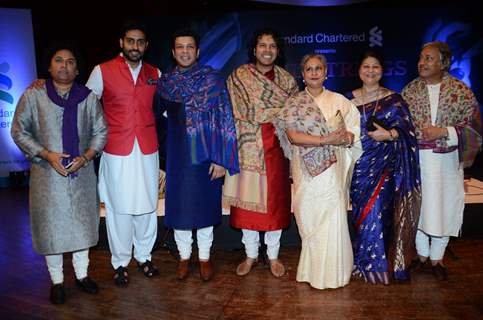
[86,58,161,215]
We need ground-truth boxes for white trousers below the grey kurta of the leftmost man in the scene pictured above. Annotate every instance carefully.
[45,249,89,284]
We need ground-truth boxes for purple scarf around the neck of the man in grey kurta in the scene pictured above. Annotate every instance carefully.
[45,79,91,172]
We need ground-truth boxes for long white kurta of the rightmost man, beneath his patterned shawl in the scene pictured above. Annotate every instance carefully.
[418,84,465,237]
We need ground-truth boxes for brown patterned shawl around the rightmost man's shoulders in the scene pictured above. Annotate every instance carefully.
[402,73,482,167]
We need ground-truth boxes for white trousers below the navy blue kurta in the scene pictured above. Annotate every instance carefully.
[174,226,213,260]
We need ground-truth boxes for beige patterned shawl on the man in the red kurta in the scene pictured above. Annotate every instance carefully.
[227,64,298,174]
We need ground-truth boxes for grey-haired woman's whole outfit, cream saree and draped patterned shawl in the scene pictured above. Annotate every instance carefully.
[286,89,360,289]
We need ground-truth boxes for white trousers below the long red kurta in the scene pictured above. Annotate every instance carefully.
[242,229,282,260]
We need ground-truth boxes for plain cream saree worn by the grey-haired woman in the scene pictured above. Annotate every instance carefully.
[291,90,362,289]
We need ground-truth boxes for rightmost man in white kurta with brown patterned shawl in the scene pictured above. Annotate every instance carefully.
[402,42,481,280]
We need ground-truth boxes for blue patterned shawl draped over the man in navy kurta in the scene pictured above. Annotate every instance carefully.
[157,64,239,174]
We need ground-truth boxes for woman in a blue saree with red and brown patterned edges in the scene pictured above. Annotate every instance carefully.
[348,50,421,285]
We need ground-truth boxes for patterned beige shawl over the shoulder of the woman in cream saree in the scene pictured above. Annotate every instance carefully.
[276,90,337,177]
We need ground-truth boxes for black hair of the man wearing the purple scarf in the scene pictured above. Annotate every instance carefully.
[40,41,85,83]
